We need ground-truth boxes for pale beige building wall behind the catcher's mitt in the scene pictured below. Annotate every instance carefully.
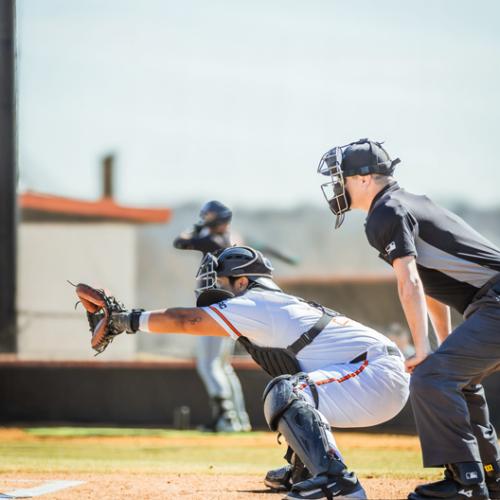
[18,223,137,360]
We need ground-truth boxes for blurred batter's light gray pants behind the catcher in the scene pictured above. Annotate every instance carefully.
[196,337,248,423]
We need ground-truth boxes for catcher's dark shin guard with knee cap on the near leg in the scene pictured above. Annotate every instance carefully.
[264,375,347,476]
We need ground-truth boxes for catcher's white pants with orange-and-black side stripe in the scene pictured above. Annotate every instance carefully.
[302,346,410,427]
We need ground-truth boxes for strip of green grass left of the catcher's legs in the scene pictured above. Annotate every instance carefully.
[0,427,283,474]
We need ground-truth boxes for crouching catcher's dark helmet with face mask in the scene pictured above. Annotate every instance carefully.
[196,246,280,306]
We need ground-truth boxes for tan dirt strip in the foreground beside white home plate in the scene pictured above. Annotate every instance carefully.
[0,473,416,500]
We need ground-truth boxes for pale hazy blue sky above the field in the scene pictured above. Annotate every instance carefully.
[17,0,500,208]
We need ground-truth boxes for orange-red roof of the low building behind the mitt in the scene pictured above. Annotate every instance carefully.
[19,191,172,224]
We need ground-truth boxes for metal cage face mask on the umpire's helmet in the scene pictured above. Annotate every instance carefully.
[318,147,351,229]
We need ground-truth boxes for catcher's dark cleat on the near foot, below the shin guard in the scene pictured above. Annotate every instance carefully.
[284,472,367,500]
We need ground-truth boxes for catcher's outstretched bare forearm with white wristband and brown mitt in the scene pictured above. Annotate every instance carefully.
[76,283,227,354]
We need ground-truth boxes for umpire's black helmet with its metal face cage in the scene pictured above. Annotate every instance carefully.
[318,139,401,229]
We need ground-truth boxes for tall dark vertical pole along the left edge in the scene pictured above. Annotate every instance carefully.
[0,0,17,353]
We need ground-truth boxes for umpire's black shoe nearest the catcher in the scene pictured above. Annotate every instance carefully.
[408,462,490,500]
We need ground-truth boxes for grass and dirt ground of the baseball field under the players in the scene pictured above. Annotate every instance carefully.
[0,428,436,500]
